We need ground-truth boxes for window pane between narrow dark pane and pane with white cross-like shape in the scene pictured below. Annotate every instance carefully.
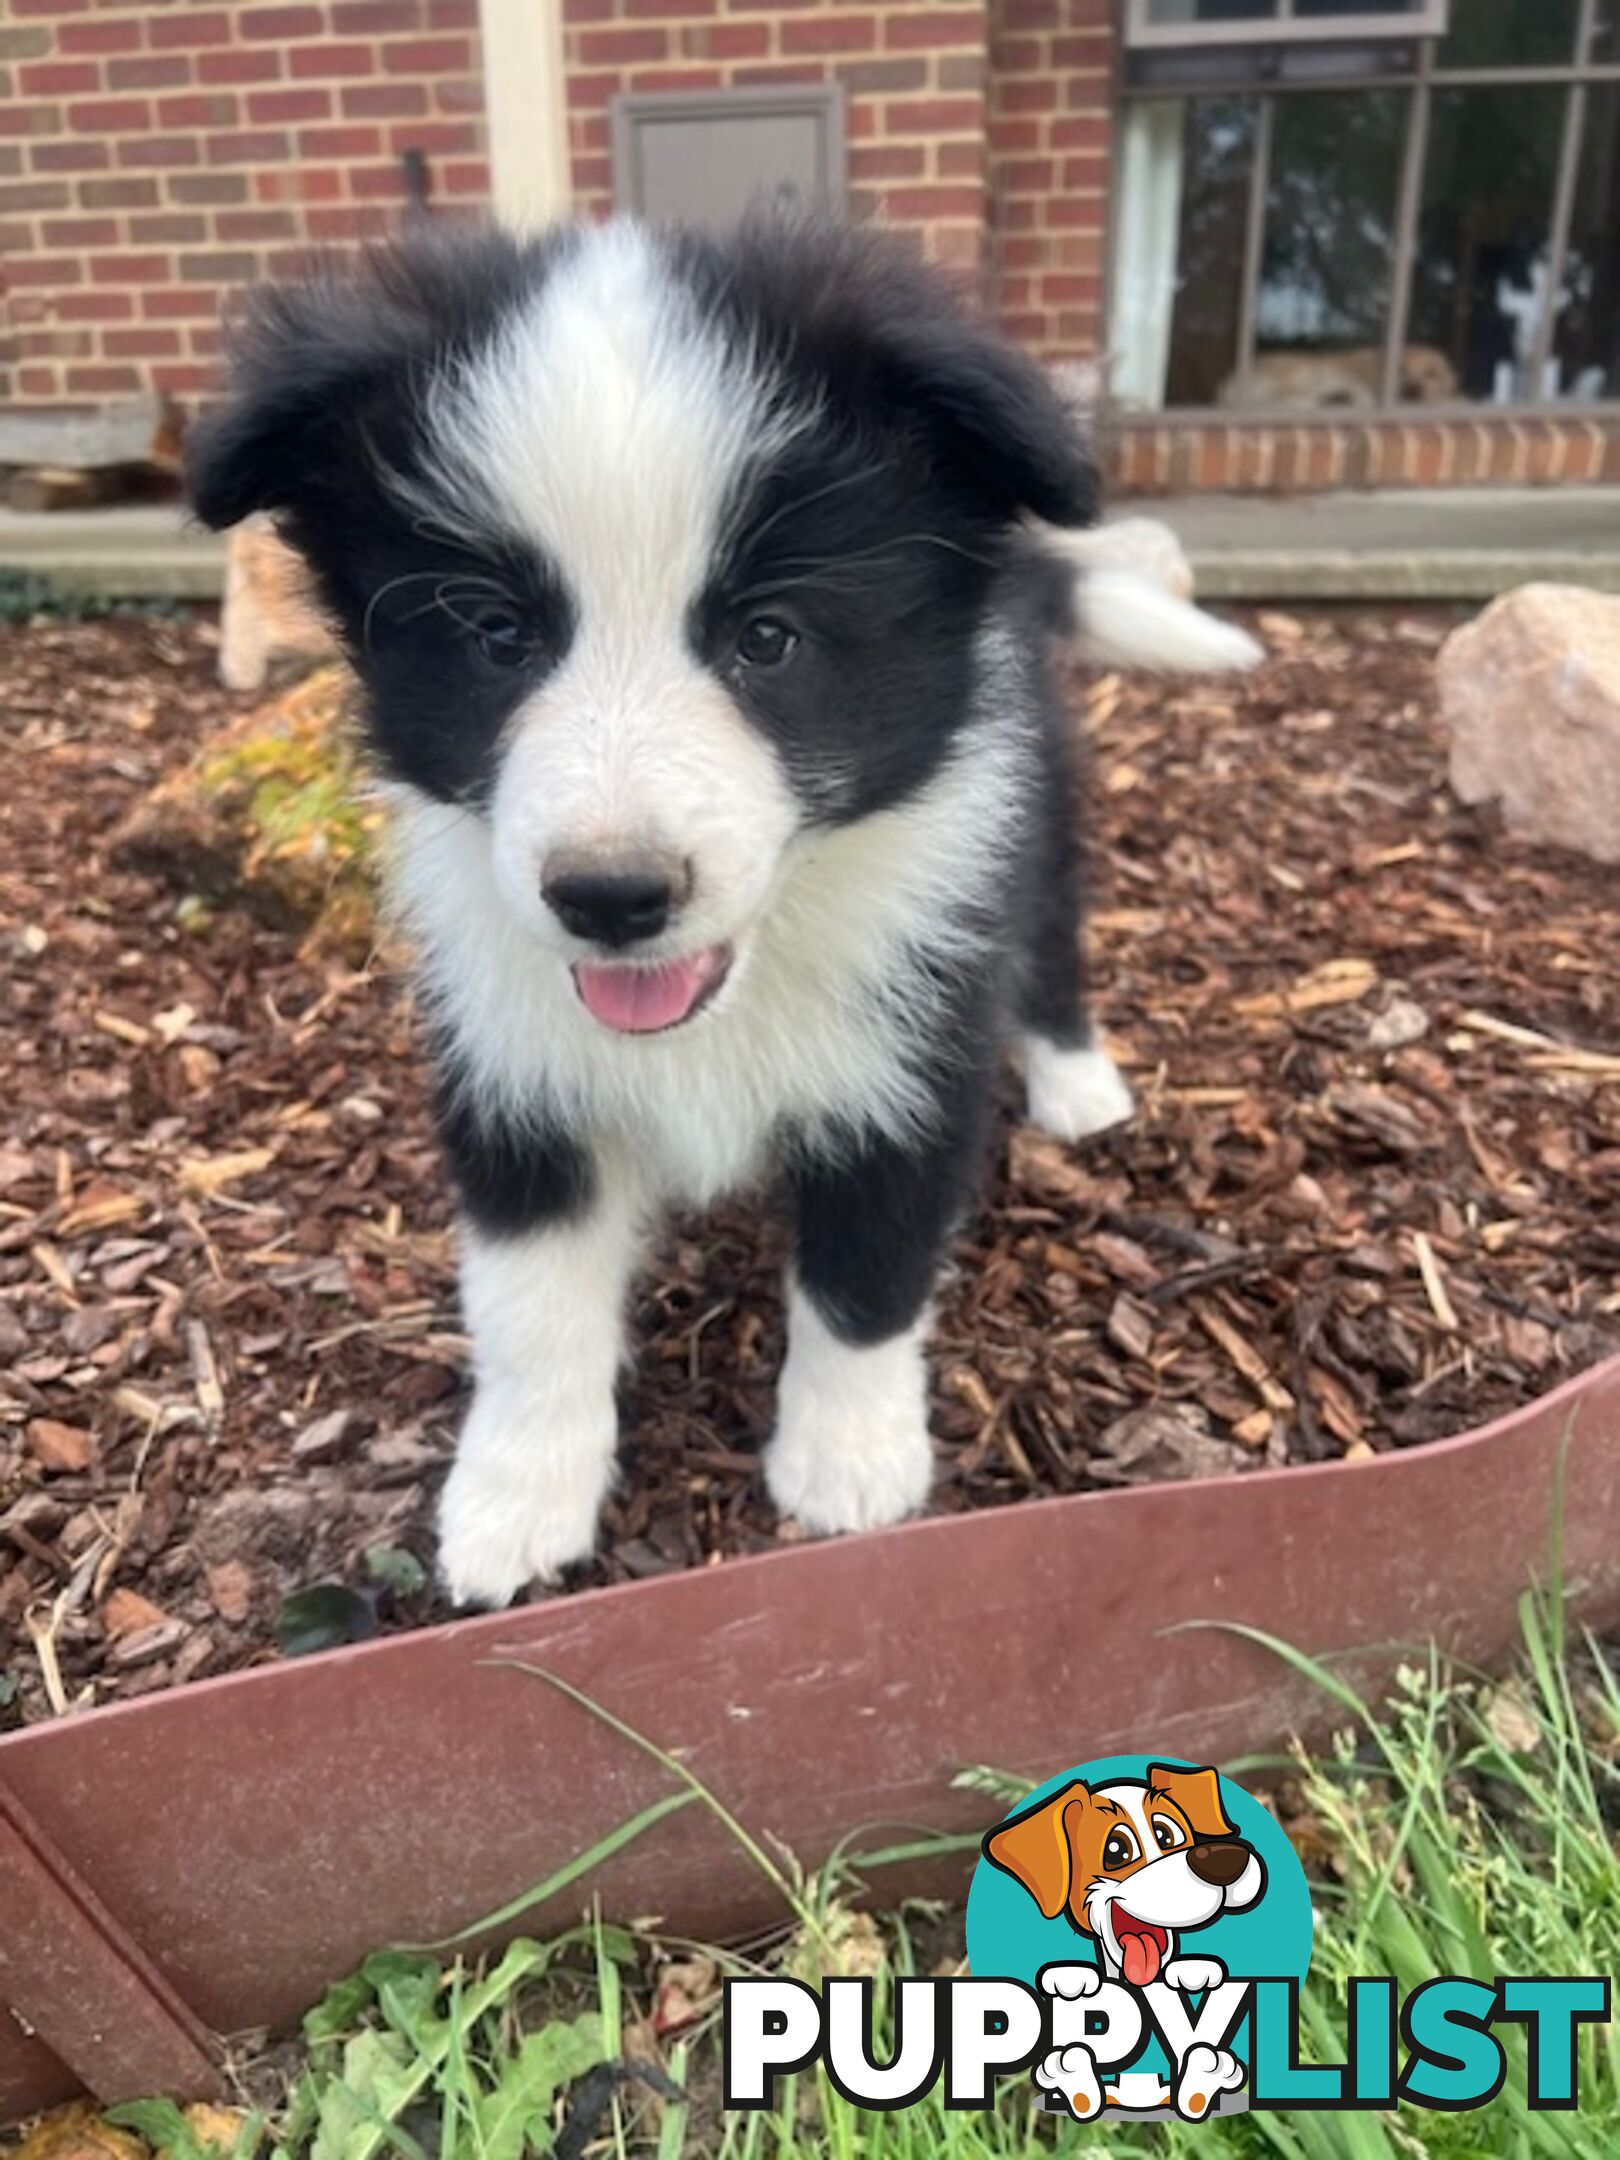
[1218,91,1406,408]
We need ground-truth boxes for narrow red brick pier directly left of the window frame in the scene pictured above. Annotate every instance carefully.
[989,0,1117,361]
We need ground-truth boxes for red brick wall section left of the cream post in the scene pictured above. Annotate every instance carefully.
[0,0,488,406]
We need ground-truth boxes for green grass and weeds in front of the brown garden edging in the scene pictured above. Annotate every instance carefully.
[108,1596,1620,2160]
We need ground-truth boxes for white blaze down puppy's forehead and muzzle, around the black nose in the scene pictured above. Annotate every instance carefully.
[412,225,806,957]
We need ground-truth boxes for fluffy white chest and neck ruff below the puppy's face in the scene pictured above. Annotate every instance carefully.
[389,626,1030,1203]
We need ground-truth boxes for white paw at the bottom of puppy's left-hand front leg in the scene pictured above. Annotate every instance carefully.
[438,1402,613,1605]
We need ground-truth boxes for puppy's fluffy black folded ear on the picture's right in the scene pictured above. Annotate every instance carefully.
[879,315,1097,525]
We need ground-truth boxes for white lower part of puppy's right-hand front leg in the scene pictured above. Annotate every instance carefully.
[765,1283,933,1534]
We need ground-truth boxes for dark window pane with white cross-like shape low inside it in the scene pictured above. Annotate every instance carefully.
[1402,87,1568,404]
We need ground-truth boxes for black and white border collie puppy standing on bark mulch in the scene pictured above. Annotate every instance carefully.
[190,220,1177,1605]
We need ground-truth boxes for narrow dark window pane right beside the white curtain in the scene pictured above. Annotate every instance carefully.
[1164,97,1259,404]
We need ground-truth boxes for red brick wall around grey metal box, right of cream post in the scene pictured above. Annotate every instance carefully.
[564,0,989,272]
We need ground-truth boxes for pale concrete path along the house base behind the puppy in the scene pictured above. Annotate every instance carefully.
[0,488,1620,600]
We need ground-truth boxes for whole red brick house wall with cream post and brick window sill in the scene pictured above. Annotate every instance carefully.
[0,0,1620,495]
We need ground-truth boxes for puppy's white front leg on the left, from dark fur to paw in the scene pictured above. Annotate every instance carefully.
[438,1188,652,1605]
